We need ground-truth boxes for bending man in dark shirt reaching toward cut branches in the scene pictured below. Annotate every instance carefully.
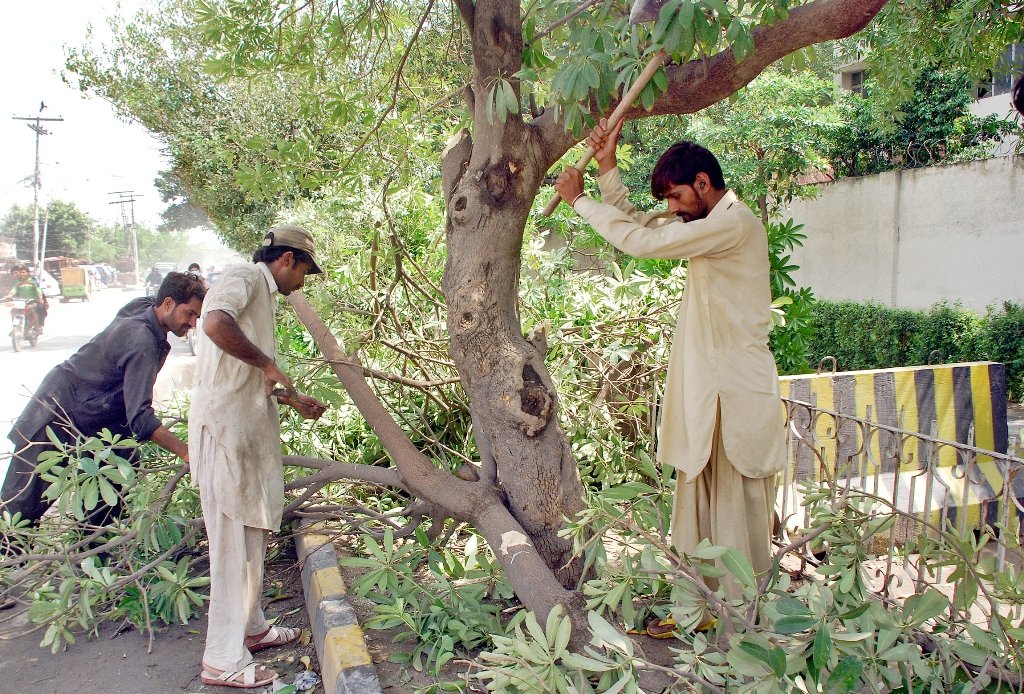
[0,272,206,523]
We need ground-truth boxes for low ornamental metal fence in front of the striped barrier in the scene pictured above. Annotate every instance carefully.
[779,398,1024,593]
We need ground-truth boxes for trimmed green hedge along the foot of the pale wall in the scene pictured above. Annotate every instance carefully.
[809,299,1024,400]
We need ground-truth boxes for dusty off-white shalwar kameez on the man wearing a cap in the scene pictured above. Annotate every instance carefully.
[188,263,285,671]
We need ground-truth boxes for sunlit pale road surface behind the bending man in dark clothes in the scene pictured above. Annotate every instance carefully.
[0,289,195,479]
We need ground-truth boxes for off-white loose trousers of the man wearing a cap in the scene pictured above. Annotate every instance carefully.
[190,427,270,670]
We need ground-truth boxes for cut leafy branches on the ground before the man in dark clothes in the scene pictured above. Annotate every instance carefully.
[0,419,209,653]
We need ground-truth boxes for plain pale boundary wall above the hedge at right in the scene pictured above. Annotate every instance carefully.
[790,157,1024,311]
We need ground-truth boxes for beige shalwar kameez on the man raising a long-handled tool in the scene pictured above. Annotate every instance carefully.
[575,170,785,597]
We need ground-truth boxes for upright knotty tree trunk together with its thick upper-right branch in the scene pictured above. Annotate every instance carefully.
[441,0,886,587]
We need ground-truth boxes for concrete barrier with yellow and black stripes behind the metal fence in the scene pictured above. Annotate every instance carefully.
[779,361,1011,524]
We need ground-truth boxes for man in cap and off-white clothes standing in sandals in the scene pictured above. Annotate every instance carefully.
[188,226,326,687]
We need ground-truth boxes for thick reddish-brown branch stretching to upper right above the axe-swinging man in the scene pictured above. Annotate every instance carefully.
[535,0,888,168]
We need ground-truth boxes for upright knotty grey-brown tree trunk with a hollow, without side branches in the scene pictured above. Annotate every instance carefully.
[441,0,584,588]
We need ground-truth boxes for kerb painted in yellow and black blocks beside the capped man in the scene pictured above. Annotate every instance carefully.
[295,524,381,694]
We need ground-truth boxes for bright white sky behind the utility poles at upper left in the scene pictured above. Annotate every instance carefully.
[0,0,168,232]
